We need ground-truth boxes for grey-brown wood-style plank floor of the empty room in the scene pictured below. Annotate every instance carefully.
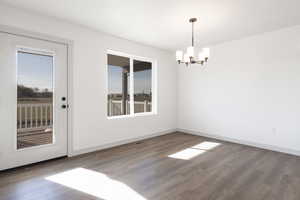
[0,133,300,200]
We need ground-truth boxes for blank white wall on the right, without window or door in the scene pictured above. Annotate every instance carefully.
[178,26,300,151]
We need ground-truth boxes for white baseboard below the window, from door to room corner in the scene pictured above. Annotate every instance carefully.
[68,129,177,157]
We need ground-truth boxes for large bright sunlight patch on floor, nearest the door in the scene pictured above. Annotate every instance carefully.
[45,168,147,200]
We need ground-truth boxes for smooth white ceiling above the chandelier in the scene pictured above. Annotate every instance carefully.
[0,0,300,51]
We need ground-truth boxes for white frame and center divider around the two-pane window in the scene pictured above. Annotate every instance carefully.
[106,50,157,119]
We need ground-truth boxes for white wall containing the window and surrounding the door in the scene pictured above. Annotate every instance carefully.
[0,5,177,155]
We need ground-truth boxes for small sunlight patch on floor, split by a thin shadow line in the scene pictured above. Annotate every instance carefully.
[168,141,221,160]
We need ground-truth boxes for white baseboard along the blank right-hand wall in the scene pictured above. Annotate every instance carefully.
[177,128,300,156]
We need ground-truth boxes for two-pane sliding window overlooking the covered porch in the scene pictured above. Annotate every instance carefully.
[107,51,155,117]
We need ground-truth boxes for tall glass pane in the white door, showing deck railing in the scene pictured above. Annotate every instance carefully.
[16,50,54,149]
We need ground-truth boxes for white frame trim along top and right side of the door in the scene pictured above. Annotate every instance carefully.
[0,24,74,157]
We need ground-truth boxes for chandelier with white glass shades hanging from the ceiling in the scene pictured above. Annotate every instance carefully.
[176,18,209,66]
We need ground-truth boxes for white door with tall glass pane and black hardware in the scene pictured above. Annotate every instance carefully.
[0,32,68,170]
